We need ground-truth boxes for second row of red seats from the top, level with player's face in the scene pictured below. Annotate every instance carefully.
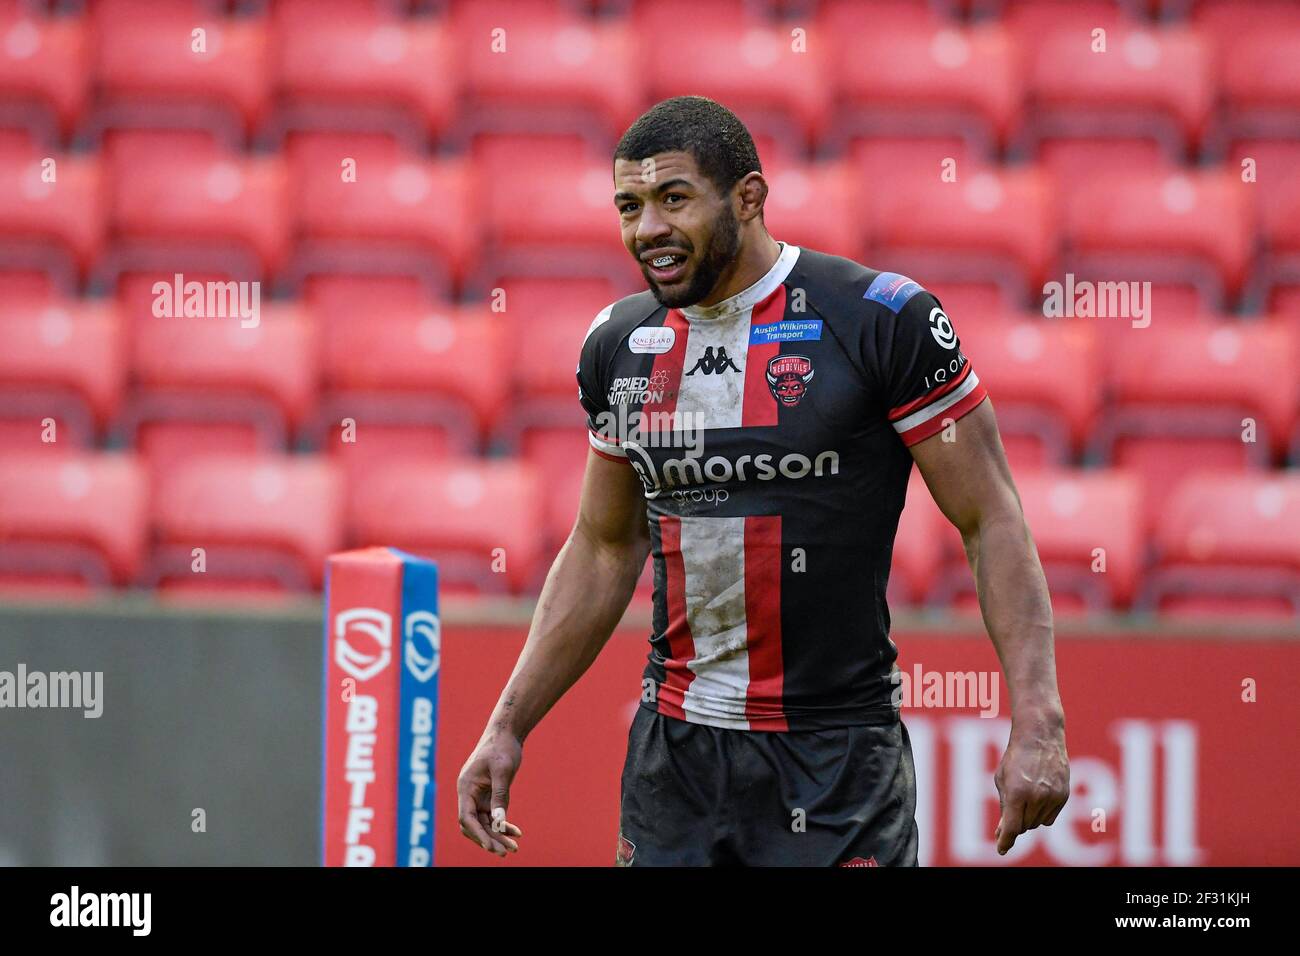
[0,141,1300,307]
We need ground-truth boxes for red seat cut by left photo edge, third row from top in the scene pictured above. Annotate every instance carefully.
[0,302,126,451]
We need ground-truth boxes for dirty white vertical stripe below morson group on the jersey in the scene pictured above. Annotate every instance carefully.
[680,518,749,730]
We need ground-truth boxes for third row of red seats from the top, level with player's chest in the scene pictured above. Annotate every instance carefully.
[0,299,1300,470]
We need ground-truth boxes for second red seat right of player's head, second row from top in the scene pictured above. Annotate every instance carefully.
[863,169,1057,293]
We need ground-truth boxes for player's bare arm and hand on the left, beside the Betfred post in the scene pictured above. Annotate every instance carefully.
[458,451,650,855]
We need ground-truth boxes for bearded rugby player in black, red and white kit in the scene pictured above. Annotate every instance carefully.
[458,96,1070,866]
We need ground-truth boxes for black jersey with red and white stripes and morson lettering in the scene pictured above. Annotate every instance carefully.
[577,243,985,731]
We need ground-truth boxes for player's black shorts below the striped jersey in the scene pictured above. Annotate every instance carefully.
[616,708,917,866]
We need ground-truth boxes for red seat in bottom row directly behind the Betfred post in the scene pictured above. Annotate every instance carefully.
[348,458,545,593]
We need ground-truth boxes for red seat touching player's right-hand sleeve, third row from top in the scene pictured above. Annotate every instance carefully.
[958,319,1101,464]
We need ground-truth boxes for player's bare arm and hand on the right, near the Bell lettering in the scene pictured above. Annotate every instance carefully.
[911,401,1070,853]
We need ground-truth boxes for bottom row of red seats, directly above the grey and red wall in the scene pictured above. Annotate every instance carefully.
[0,453,1300,615]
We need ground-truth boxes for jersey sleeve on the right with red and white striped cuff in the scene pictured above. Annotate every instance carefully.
[868,273,988,447]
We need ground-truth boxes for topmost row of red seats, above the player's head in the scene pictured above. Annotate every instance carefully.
[0,0,1300,155]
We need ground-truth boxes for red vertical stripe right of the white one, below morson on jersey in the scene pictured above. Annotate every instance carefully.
[745,515,789,731]
